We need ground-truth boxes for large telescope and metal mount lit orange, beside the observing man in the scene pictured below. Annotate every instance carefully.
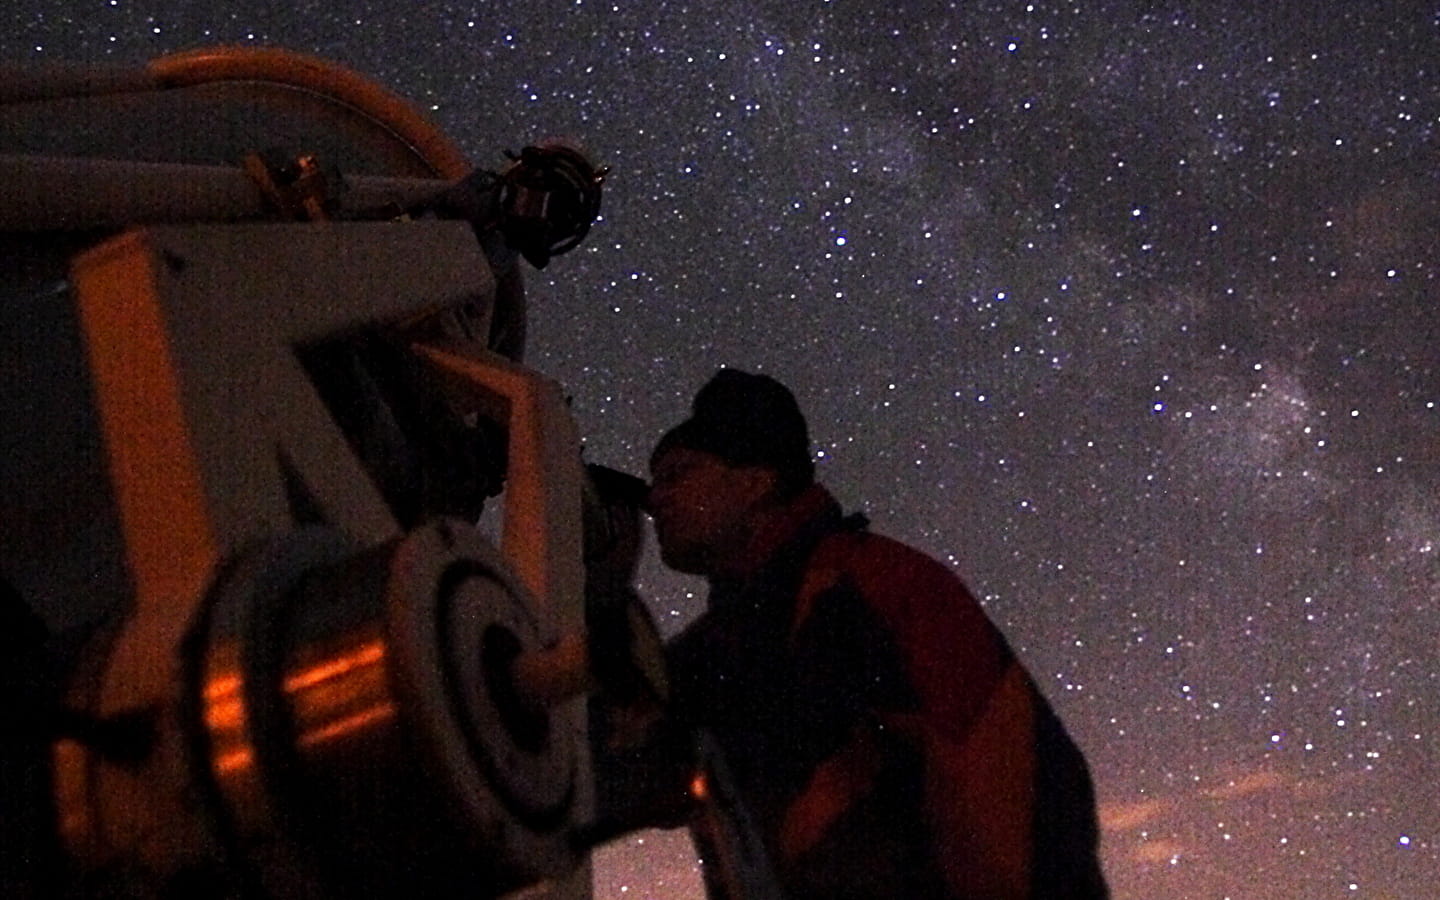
[0,48,645,899]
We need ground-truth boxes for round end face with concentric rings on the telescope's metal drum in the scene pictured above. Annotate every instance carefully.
[387,520,583,876]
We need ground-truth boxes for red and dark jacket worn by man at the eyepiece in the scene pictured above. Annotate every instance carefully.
[668,487,1107,900]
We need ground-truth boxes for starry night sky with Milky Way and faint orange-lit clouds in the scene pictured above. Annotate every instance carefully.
[0,0,1440,900]
